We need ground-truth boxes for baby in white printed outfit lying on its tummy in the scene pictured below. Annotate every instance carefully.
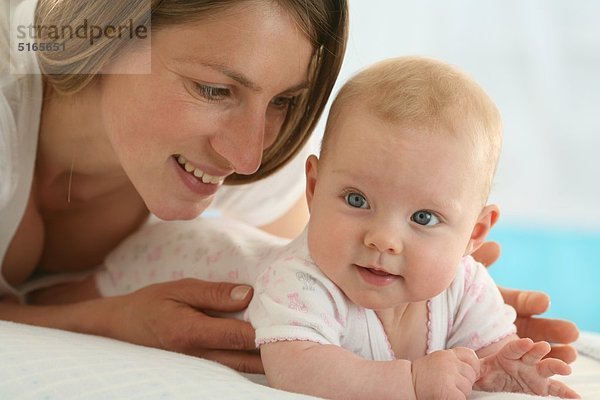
[62,57,578,399]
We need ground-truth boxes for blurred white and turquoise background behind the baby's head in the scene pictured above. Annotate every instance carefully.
[318,0,600,332]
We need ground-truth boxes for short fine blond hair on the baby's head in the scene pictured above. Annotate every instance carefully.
[321,57,502,197]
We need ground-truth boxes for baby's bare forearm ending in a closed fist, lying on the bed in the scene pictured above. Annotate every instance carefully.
[260,341,478,399]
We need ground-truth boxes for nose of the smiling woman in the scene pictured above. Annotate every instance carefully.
[211,110,266,175]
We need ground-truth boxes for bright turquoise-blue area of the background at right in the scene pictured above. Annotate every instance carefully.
[489,223,600,332]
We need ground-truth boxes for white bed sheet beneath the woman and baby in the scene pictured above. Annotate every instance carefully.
[0,321,600,400]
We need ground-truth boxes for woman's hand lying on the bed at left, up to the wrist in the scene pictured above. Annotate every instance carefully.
[103,279,263,373]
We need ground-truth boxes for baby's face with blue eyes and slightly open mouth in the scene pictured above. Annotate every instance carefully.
[307,108,482,310]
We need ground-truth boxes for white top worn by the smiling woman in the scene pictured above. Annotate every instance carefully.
[0,0,315,295]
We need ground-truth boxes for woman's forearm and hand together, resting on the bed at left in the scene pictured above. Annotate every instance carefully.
[20,276,263,373]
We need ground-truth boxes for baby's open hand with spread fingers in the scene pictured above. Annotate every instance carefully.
[475,339,579,399]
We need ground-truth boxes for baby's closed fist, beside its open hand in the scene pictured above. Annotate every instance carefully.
[412,347,479,400]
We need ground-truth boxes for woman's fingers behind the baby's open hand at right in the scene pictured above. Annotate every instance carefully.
[473,242,579,363]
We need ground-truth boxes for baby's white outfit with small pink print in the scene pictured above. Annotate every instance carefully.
[96,219,516,361]
